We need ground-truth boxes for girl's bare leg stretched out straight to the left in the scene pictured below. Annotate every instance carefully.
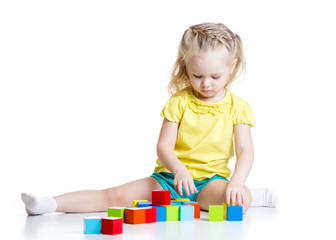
[23,177,162,215]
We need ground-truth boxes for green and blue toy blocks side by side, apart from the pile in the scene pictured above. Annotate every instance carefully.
[209,203,243,221]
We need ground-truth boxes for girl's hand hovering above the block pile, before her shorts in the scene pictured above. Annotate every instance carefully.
[174,165,198,196]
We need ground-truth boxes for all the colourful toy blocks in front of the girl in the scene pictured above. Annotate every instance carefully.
[84,190,243,235]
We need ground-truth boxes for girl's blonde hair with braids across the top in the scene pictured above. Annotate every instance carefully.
[168,23,246,95]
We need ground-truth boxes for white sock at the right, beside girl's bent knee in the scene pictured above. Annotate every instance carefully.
[251,188,279,207]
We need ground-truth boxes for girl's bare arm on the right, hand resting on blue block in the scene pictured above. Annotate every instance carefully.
[226,124,254,205]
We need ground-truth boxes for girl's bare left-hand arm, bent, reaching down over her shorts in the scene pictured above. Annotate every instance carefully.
[156,118,198,196]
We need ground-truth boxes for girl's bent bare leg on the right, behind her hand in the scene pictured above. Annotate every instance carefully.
[196,179,252,213]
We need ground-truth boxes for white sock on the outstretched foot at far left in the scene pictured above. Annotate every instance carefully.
[21,193,57,215]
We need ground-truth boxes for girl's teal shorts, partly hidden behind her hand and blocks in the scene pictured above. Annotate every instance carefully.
[151,172,229,202]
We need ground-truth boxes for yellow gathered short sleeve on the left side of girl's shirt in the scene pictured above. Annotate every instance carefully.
[161,96,186,123]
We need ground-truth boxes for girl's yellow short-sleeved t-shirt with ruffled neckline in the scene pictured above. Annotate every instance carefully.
[154,89,255,180]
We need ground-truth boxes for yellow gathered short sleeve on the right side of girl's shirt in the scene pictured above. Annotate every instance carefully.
[232,96,256,127]
